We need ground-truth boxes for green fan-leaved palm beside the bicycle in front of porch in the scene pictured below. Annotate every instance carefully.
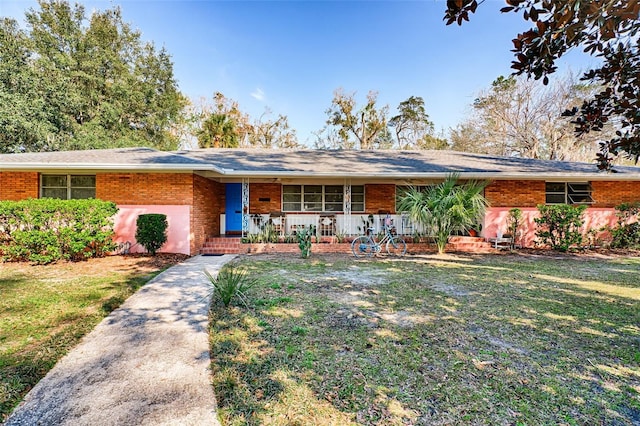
[398,173,488,254]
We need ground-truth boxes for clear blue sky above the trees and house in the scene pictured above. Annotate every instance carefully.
[0,0,592,146]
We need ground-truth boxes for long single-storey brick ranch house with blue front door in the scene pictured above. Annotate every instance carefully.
[0,148,640,255]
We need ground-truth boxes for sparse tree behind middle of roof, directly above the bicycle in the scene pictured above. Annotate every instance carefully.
[326,89,389,149]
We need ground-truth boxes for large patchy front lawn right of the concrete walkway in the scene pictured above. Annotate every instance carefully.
[211,255,640,425]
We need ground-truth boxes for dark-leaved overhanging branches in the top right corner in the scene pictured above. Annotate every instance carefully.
[444,0,640,169]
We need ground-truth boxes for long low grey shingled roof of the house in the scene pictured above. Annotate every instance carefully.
[0,148,640,180]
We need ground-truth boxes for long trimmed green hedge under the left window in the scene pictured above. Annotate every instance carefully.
[0,198,118,263]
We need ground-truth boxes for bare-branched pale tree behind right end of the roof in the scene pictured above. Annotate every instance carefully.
[451,74,610,161]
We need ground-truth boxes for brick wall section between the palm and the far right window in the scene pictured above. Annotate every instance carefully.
[484,180,545,207]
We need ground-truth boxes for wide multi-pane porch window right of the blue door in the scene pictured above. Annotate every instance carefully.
[282,185,364,212]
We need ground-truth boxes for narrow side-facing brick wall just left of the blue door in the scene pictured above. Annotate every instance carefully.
[190,175,224,254]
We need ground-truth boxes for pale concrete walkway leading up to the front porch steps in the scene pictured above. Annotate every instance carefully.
[5,255,234,426]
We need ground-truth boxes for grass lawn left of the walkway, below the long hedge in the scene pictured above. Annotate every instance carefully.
[0,257,178,421]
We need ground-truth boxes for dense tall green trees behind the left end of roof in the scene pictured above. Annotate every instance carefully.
[0,0,185,152]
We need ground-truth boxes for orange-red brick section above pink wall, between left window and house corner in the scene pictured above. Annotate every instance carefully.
[96,173,193,205]
